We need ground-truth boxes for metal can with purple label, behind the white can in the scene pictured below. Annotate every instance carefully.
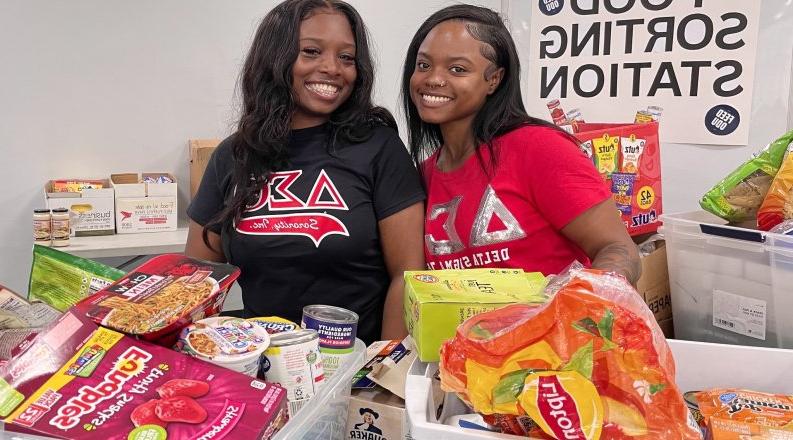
[301,305,358,377]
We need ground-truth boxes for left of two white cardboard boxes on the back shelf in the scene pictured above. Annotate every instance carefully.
[44,179,116,237]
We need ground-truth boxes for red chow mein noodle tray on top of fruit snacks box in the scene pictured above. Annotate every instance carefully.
[76,254,240,346]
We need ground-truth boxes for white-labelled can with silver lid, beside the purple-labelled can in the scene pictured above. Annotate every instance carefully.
[261,329,325,418]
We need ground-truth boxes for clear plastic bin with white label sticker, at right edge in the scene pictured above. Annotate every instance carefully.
[662,211,793,348]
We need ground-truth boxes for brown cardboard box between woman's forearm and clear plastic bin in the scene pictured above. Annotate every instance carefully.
[636,240,672,337]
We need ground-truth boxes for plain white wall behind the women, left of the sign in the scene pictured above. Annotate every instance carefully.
[0,0,500,294]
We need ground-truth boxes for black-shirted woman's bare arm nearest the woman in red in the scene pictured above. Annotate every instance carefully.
[378,202,425,340]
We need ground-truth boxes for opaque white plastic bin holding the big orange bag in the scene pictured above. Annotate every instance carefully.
[405,340,793,440]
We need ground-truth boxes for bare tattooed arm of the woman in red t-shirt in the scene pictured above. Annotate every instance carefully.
[562,199,642,286]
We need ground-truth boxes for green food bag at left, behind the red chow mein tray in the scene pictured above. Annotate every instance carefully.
[28,245,126,312]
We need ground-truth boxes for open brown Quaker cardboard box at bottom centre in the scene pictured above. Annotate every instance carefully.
[347,336,416,440]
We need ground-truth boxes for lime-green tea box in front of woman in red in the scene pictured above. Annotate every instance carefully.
[404,269,547,362]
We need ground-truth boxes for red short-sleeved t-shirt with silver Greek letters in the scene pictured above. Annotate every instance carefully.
[424,126,611,275]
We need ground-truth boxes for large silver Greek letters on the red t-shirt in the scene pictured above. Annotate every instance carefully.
[424,185,526,256]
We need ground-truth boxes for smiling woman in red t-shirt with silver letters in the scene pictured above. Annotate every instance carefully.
[402,5,641,283]
